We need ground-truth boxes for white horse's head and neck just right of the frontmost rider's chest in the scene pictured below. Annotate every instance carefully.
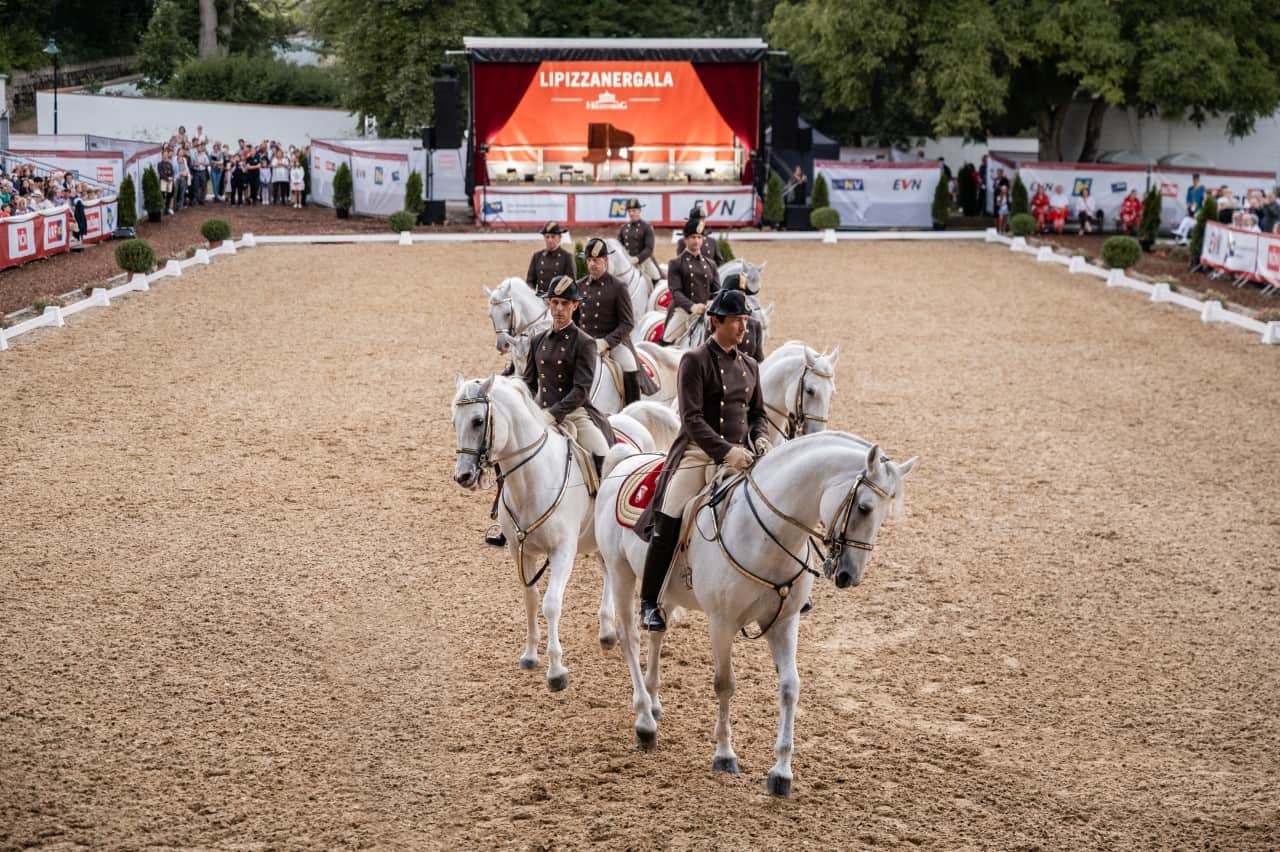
[760,340,840,445]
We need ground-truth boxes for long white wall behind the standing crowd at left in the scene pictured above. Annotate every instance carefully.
[36,92,358,146]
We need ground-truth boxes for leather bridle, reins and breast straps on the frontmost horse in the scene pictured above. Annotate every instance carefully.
[712,457,891,638]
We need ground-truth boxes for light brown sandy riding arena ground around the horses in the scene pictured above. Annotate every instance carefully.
[0,236,1280,849]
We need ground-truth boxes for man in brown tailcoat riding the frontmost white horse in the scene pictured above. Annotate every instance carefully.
[635,290,769,631]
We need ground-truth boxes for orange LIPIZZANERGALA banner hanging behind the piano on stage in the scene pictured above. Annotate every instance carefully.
[489,61,733,162]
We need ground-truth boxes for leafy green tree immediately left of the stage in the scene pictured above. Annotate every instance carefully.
[307,0,524,137]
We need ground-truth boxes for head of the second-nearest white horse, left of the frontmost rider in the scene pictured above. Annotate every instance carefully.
[453,372,541,489]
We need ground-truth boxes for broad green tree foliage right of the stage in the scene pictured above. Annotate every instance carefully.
[768,0,1280,159]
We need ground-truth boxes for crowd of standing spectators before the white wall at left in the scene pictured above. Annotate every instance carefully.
[156,125,310,215]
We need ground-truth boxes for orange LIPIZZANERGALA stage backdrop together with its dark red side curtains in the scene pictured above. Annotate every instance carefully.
[472,60,760,185]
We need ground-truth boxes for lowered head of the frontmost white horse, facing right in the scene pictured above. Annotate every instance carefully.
[824,435,915,588]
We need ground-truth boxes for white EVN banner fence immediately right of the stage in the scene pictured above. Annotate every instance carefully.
[813,160,942,228]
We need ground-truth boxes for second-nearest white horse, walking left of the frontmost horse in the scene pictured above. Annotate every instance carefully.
[453,374,609,692]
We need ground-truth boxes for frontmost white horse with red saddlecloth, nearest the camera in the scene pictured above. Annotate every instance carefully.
[595,432,915,796]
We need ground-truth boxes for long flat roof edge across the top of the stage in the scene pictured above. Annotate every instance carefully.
[462,36,769,63]
